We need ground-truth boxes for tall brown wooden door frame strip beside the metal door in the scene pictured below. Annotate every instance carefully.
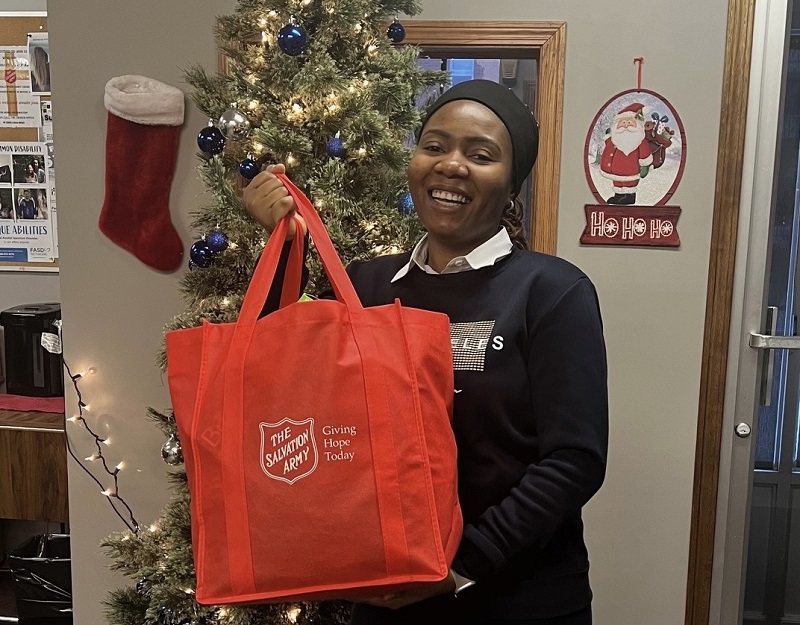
[685,0,756,625]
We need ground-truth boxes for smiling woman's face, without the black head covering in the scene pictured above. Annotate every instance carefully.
[408,100,512,255]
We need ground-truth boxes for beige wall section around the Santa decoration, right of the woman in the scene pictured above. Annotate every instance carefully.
[412,0,727,625]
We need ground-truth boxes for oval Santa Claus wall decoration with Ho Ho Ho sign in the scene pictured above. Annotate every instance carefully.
[581,88,686,247]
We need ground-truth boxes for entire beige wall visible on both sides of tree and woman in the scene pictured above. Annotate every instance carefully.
[49,0,726,625]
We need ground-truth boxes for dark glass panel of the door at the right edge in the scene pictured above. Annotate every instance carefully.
[743,7,800,625]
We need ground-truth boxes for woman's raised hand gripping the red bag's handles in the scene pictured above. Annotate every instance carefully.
[242,163,306,241]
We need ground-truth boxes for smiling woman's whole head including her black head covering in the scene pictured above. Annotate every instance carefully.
[408,80,539,273]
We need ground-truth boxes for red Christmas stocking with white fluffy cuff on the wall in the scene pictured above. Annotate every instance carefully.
[99,76,183,271]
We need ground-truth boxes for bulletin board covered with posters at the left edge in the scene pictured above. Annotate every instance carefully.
[0,12,58,271]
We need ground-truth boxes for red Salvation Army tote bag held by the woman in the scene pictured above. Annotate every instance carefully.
[166,176,462,604]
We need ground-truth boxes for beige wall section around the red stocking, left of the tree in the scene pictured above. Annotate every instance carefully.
[48,0,231,625]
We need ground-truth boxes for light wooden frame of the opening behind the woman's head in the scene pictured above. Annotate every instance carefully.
[403,20,567,254]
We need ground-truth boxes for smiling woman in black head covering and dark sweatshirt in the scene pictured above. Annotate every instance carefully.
[244,80,608,625]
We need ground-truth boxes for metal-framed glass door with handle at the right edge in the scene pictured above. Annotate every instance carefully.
[712,0,800,625]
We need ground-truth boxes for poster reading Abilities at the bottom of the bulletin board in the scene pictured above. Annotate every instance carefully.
[0,142,57,265]
